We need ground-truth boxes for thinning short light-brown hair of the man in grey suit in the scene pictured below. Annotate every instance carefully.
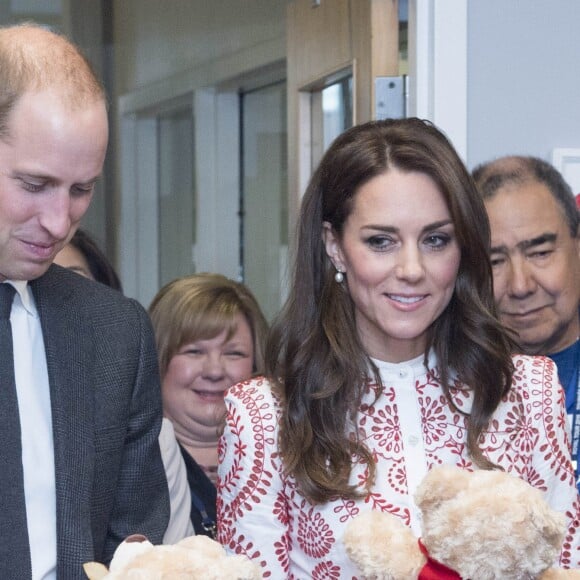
[0,23,106,138]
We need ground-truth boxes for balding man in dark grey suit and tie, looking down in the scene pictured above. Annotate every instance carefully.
[0,25,169,580]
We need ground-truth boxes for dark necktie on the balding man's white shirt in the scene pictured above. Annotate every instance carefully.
[0,283,32,580]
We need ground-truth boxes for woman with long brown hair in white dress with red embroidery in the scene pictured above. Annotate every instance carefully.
[218,118,580,578]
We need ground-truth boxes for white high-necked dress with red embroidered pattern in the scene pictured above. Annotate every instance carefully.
[218,355,580,580]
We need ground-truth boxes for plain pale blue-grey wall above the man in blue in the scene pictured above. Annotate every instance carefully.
[467,0,580,168]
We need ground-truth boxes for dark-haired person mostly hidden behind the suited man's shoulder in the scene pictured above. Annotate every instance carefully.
[54,228,123,292]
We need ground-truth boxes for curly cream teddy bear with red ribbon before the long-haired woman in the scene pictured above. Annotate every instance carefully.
[343,466,580,580]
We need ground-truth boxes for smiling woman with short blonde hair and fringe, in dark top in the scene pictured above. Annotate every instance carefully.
[149,273,267,537]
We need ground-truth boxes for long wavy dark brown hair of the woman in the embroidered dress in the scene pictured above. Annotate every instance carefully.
[266,119,513,503]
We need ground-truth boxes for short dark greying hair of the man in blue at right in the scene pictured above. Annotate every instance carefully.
[472,155,579,238]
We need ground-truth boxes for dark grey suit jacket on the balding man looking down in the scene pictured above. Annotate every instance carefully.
[28,265,169,580]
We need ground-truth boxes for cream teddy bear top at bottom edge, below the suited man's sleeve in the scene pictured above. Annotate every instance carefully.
[83,534,262,580]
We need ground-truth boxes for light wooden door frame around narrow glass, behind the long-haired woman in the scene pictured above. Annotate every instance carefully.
[286,0,399,232]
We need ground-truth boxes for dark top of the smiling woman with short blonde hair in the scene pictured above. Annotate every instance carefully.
[179,445,217,539]
